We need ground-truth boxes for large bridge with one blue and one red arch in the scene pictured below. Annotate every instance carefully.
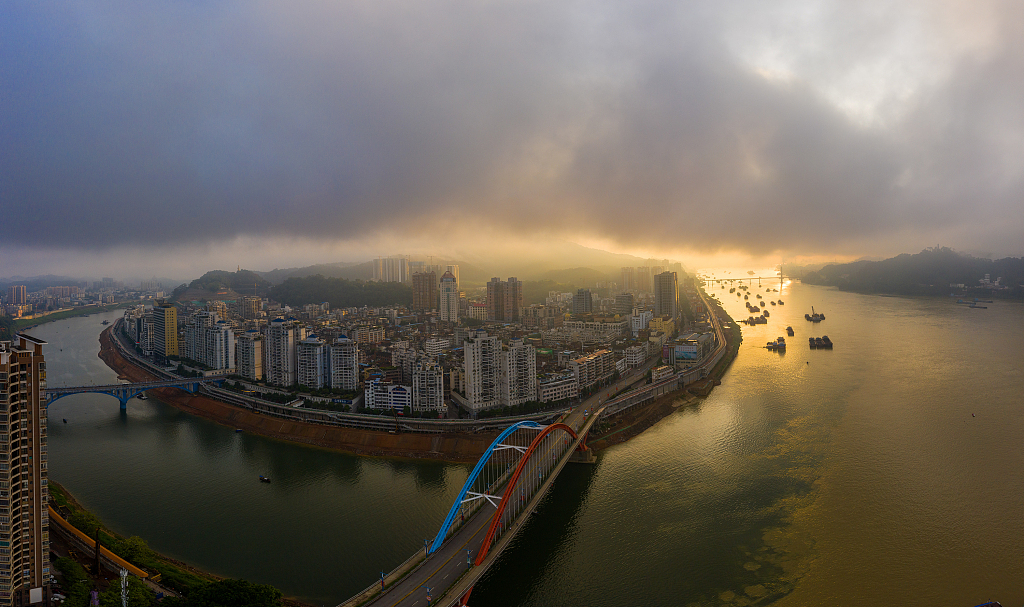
[341,407,604,607]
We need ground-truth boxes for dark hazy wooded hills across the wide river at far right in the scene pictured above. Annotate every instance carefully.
[802,247,1024,297]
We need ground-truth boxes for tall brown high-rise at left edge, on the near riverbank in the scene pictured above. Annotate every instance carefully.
[0,334,50,605]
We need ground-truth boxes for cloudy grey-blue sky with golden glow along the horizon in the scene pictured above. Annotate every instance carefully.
[0,0,1024,276]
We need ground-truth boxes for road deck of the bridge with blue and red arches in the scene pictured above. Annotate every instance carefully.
[356,403,613,607]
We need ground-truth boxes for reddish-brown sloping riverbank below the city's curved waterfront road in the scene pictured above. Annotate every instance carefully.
[99,329,497,462]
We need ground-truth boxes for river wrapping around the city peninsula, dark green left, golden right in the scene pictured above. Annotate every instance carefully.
[30,278,1024,607]
